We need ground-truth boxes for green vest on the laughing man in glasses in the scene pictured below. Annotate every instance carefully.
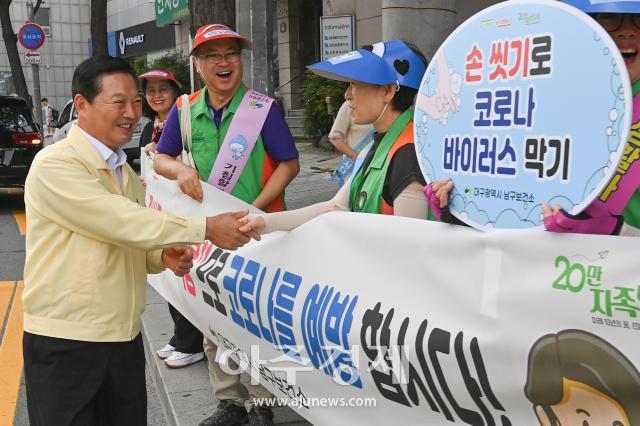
[178,83,267,203]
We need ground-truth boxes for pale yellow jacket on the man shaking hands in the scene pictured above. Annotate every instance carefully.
[22,126,206,342]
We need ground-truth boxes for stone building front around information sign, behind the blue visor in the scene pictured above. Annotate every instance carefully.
[277,0,502,110]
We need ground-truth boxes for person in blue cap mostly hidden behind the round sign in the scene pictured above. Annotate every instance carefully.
[425,0,640,236]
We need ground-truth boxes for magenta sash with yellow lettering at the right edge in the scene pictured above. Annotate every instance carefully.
[594,94,640,215]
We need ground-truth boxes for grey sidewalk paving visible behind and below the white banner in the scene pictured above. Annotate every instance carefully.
[142,144,338,426]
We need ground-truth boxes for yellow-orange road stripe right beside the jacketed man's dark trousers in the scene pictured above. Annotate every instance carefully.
[0,281,24,425]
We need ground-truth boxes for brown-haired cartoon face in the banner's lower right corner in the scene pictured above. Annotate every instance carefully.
[524,330,640,426]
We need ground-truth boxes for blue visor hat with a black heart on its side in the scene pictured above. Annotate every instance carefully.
[307,40,426,89]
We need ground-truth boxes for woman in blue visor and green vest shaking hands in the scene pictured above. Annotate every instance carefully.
[240,40,436,233]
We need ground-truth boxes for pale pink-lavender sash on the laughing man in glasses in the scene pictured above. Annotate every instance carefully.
[207,90,273,193]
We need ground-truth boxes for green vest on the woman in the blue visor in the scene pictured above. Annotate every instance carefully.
[349,108,413,213]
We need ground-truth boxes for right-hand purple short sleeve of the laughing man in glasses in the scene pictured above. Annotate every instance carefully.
[262,102,299,163]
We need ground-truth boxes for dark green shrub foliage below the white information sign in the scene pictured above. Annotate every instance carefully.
[302,71,347,136]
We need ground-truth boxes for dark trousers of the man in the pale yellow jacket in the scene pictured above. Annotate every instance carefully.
[22,332,147,426]
